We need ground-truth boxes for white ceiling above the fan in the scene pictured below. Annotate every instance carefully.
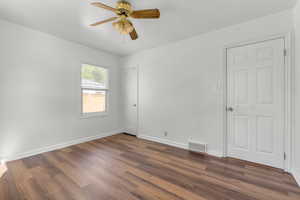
[0,0,297,55]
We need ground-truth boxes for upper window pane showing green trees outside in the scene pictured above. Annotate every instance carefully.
[81,64,108,89]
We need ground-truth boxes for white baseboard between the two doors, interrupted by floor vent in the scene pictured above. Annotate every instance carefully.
[138,135,223,157]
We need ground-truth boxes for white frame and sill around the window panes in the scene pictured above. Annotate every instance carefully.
[79,62,110,119]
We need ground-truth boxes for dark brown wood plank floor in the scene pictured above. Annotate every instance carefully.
[0,134,300,200]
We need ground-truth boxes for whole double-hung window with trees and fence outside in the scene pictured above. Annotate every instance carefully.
[81,64,109,115]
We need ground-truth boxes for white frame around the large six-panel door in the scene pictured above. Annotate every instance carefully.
[222,32,295,172]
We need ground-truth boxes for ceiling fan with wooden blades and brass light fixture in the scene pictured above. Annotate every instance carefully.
[90,0,160,40]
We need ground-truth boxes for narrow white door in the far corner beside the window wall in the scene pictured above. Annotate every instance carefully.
[122,67,138,135]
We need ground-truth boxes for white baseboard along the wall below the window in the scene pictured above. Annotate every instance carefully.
[2,129,123,161]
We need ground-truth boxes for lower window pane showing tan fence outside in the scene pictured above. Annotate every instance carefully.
[82,89,106,113]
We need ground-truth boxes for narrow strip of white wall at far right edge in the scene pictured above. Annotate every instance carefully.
[293,3,300,181]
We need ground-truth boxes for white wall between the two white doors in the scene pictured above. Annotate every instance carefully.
[124,11,293,155]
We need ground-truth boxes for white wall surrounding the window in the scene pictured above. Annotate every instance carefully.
[0,18,121,157]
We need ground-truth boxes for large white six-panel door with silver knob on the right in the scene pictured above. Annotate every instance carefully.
[227,39,284,168]
